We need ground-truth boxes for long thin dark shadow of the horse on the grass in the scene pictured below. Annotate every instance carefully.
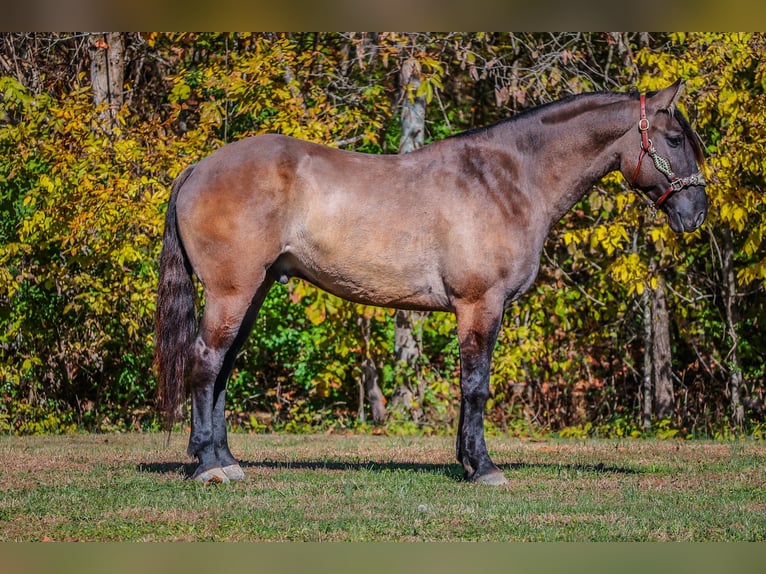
[136,460,642,481]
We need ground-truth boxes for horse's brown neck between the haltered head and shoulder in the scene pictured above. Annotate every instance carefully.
[516,96,638,225]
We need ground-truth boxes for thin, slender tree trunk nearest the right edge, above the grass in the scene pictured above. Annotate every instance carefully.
[721,225,745,428]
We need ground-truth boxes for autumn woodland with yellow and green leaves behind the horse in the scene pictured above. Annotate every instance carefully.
[0,33,766,438]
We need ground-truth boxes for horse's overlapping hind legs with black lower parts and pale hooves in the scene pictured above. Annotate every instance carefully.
[188,279,271,482]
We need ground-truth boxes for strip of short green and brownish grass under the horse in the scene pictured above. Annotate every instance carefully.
[0,434,766,542]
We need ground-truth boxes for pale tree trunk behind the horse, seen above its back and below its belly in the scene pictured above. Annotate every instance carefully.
[391,58,426,421]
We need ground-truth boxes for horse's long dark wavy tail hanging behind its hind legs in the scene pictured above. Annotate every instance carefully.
[154,166,197,430]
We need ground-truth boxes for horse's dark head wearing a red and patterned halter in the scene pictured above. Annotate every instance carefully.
[621,82,707,233]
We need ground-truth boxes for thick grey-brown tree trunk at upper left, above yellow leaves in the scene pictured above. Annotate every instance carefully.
[88,32,125,133]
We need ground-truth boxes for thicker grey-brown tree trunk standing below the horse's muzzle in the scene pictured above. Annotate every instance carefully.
[651,273,675,419]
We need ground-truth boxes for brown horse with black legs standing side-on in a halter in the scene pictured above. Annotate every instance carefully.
[156,83,707,484]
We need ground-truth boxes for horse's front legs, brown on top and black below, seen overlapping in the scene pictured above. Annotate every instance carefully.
[455,298,508,485]
